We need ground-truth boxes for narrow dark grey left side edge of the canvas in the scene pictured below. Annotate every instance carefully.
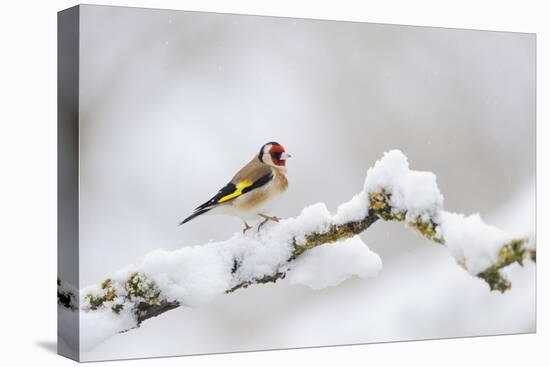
[57,5,80,361]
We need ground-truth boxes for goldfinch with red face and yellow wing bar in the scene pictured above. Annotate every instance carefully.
[179,141,291,234]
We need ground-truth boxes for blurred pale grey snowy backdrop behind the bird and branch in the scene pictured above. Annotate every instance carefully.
[74,6,535,359]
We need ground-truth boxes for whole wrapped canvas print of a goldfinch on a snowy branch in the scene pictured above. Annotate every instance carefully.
[57,5,536,361]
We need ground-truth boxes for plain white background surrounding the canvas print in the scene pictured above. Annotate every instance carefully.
[0,1,548,366]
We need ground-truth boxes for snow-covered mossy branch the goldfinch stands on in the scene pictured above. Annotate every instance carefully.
[58,150,536,346]
